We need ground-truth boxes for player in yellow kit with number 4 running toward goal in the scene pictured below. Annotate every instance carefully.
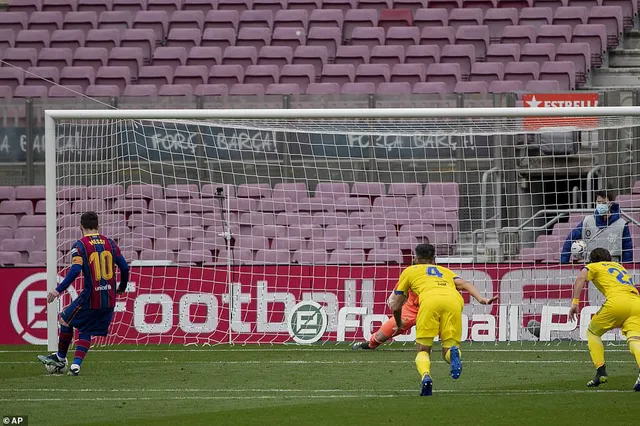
[389,244,498,396]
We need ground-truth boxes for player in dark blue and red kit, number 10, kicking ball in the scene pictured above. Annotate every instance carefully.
[38,212,129,376]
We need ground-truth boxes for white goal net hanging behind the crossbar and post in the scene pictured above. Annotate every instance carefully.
[45,107,640,345]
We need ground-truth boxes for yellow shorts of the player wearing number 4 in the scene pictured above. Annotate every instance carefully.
[416,295,464,342]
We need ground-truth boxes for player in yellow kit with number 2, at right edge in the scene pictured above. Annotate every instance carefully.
[569,248,640,392]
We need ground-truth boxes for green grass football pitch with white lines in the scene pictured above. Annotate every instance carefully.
[0,342,640,426]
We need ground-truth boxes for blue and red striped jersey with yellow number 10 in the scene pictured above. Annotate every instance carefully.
[71,234,126,309]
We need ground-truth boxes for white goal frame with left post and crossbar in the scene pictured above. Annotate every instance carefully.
[44,106,640,350]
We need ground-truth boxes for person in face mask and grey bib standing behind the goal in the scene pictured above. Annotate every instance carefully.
[560,191,633,263]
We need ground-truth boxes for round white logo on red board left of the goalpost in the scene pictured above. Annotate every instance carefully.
[9,272,75,345]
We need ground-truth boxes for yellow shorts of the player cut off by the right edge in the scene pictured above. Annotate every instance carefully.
[589,296,640,336]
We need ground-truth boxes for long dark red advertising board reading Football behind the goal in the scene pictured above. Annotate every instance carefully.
[0,264,640,344]
